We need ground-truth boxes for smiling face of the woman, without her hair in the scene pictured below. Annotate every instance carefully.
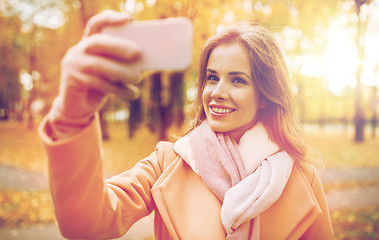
[202,43,259,141]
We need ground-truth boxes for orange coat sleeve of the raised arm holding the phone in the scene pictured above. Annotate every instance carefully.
[39,115,168,239]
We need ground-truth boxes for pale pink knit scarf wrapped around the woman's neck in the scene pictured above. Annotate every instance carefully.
[174,121,293,239]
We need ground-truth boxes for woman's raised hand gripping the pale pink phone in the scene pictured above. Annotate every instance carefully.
[50,11,141,139]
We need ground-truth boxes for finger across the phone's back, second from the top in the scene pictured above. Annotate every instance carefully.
[83,34,141,62]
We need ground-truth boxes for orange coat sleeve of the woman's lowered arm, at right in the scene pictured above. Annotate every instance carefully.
[300,166,334,240]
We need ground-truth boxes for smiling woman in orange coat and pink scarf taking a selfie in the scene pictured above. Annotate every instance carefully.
[40,12,333,239]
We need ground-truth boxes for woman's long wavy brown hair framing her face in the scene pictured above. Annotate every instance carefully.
[192,24,307,161]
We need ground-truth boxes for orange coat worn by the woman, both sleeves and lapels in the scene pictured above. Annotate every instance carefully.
[40,119,333,240]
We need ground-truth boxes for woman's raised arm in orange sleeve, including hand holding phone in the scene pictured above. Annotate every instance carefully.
[39,11,161,239]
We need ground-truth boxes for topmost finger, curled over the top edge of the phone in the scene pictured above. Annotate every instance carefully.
[84,10,132,36]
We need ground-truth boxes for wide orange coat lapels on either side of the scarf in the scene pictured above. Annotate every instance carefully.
[152,157,321,240]
